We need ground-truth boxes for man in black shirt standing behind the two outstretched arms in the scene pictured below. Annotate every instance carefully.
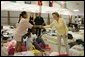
[34,14,44,35]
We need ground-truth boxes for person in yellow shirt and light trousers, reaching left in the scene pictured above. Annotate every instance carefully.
[44,12,69,54]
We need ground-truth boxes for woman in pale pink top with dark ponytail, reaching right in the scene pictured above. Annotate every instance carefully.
[14,11,33,52]
